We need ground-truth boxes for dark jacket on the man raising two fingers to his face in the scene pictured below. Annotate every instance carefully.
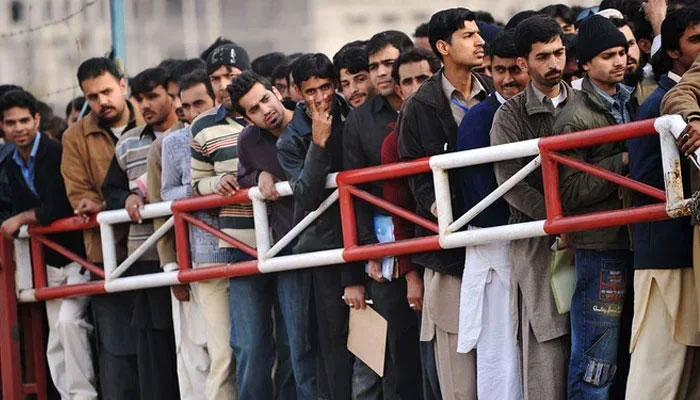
[277,95,365,287]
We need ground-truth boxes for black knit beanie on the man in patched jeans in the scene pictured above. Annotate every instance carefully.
[576,15,628,67]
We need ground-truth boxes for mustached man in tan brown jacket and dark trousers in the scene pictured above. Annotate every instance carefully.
[61,57,144,400]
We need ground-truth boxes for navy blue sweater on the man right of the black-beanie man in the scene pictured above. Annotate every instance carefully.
[627,75,693,269]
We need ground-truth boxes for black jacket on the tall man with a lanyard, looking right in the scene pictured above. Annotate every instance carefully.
[397,70,494,277]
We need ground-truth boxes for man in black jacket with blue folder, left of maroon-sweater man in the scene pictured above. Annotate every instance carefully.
[341,31,421,399]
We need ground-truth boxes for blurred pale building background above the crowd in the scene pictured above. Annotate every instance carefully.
[0,0,599,115]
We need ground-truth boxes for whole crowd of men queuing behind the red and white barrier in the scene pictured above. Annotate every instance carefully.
[0,0,700,400]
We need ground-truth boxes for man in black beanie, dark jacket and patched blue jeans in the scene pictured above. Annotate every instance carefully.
[554,15,637,399]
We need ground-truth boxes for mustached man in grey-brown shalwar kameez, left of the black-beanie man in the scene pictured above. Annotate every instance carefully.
[491,15,574,400]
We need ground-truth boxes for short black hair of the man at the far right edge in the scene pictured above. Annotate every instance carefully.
[651,7,700,80]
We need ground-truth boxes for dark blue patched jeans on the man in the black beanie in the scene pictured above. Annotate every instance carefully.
[568,250,632,400]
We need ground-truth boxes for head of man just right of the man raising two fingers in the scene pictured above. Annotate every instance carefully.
[333,46,374,108]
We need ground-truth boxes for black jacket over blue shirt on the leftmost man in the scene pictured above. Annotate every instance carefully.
[5,135,85,267]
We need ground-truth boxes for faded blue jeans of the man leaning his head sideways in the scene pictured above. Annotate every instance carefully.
[230,271,316,400]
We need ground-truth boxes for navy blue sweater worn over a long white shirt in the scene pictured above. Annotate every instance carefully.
[457,93,510,228]
